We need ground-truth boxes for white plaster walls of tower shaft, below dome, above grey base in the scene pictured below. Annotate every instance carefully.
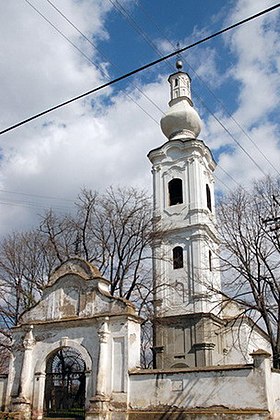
[149,139,221,322]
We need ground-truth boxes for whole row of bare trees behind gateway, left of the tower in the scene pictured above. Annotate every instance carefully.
[0,188,152,363]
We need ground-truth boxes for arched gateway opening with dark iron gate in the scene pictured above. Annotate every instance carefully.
[44,347,86,418]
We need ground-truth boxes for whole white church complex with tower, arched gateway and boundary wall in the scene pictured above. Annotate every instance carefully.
[0,60,280,420]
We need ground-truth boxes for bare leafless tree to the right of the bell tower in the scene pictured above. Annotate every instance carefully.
[218,178,280,368]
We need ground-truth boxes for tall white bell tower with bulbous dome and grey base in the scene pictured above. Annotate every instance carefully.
[148,61,222,368]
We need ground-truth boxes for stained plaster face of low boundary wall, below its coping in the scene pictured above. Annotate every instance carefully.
[130,366,268,410]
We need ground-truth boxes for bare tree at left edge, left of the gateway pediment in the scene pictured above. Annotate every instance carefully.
[0,230,56,335]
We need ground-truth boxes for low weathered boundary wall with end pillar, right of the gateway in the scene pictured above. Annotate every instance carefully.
[129,357,280,419]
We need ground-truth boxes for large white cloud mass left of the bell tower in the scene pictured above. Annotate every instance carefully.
[0,1,168,235]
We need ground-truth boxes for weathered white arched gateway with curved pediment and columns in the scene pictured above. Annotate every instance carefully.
[8,258,141,420]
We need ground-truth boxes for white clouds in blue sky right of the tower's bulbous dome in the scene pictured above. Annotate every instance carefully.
[201,0,280,188]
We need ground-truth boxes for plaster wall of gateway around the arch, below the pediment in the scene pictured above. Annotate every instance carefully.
[9,316,140,401]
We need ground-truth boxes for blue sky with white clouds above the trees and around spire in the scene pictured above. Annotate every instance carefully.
[0,0,280,239]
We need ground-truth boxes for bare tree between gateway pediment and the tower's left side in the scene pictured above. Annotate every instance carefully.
[40,188,152,300]
